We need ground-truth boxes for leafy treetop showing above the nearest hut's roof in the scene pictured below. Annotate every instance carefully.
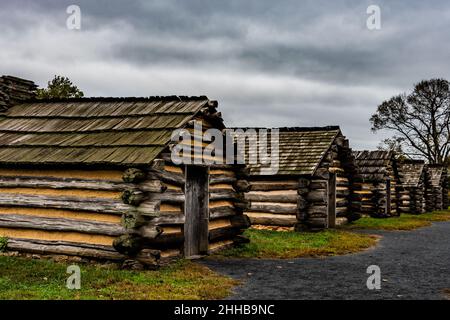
[36,75,84,99]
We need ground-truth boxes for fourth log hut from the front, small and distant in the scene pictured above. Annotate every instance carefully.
[397,160,427,214]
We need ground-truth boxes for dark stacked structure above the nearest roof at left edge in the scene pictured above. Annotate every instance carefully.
[0,76,37,112]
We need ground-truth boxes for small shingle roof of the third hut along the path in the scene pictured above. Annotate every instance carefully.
[353,150,394,181]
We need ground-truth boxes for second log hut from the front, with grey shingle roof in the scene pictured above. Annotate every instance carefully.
[232,126,358,231]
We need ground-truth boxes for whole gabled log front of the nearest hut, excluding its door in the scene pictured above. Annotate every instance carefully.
[114,116,250,259]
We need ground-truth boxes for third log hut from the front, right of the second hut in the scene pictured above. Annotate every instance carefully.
[354,151,399,217]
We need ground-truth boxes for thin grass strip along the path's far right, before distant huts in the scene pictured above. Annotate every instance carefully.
[342,210,450,230]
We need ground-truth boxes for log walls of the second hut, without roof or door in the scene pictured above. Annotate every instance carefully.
[245,137,359,231]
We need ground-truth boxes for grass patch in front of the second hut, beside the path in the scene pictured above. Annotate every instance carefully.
[216,229,377,259]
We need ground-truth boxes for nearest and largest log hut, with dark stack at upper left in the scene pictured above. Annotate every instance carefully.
[0,77,249,265]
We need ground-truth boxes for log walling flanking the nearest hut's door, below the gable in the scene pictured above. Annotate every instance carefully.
[116,157,250,263]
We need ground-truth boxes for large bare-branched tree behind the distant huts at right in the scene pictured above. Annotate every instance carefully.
[370,79,450,164]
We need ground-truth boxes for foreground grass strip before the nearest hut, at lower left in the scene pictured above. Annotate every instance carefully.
[0,256,238,300]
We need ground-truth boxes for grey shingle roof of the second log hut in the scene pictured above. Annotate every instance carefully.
[233,126,341,175]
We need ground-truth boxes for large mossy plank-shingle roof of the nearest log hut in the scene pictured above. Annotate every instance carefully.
[0,96,218,166]
